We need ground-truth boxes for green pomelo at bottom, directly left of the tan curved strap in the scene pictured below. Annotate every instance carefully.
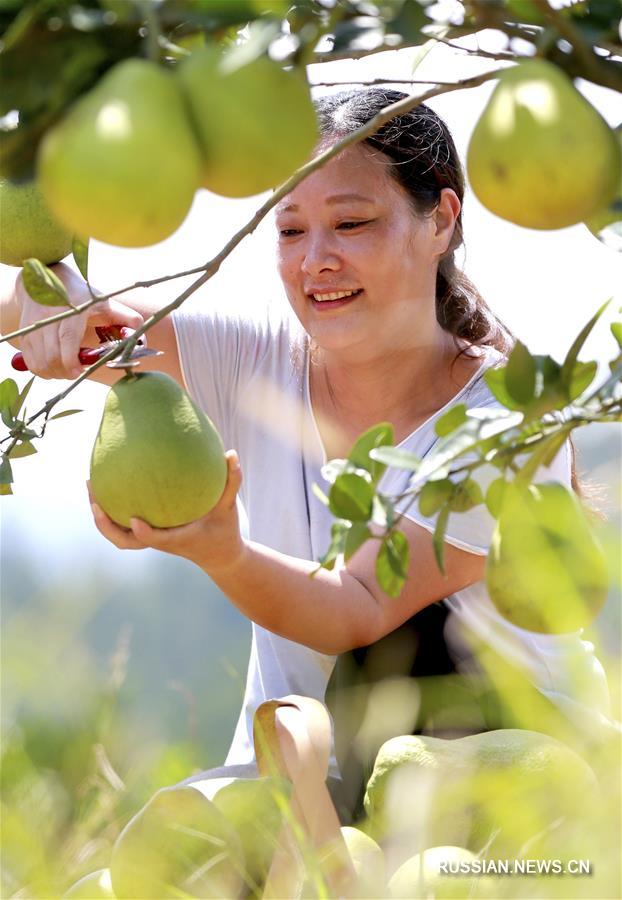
[191,777,292,897]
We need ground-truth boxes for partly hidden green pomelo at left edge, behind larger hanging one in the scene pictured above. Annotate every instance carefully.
[0,178,73,266]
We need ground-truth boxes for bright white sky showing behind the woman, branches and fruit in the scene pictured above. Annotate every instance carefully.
[0,33,622,567]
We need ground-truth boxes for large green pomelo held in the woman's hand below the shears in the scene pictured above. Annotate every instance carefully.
[91,372,227,528]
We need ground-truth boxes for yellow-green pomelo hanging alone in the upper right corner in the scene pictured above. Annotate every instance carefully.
[467,59,622,229]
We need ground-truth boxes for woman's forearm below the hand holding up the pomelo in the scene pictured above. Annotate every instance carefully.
[205,541,380,654]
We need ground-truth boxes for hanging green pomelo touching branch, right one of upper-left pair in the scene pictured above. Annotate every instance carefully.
[179,47,317,197]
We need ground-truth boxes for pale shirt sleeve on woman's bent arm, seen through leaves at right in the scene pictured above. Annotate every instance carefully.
[398,441,572,556]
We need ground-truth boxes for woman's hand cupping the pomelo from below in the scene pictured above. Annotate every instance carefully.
[87,450,245,572]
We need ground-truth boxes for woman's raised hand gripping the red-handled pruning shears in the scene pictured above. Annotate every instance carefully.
[15,263,143,380]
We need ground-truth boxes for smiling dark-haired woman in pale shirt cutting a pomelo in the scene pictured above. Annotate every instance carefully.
[6,90,607,820]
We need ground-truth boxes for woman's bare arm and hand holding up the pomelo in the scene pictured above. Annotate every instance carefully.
[89,451,486,654]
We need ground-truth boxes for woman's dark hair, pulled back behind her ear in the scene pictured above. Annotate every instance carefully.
[315,88,514,354]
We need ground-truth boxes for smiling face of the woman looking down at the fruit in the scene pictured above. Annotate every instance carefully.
[276,145,456,357]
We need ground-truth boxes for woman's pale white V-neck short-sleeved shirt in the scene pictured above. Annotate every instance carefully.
[172,303,609,770]
